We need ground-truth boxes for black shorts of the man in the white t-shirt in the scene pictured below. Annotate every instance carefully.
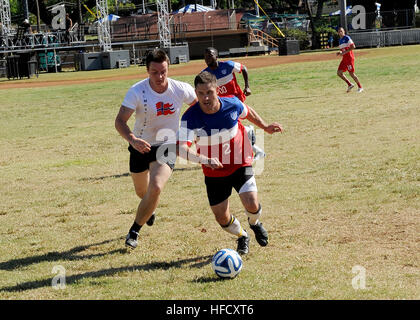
[128,144,176,173]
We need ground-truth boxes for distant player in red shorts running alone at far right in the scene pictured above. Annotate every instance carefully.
[337,27,363,92]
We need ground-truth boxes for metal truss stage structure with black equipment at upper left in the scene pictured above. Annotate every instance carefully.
[0,0,189,79]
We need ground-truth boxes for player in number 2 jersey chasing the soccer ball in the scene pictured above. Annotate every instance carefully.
[178,71,283,255]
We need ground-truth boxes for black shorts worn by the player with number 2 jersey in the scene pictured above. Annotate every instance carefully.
[204,166,257,206]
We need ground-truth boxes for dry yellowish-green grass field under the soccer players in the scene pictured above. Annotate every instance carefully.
[0,46,420,300]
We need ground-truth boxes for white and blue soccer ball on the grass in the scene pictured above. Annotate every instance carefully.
[211,249,242,278]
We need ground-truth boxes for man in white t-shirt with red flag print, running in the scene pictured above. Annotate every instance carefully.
[115,49,198,249]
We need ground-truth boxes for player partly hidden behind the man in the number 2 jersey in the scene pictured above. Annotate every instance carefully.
[203,47,265,160]
